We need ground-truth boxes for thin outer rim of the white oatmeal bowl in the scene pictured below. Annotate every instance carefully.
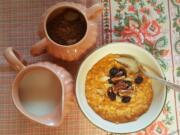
[75,42,167,134]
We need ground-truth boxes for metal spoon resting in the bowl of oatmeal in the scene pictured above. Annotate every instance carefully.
[115,54,180,92]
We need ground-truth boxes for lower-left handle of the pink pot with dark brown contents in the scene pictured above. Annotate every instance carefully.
[30,38,49,56]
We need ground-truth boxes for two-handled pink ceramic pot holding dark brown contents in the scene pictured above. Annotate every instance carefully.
[31,2,103,61]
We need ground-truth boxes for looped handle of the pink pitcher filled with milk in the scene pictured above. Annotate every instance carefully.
[3,47,26,71]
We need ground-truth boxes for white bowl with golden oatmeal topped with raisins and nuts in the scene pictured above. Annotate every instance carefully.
[76,43,166,133]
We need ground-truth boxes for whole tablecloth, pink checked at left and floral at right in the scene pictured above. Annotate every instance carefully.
[0,0,180,135]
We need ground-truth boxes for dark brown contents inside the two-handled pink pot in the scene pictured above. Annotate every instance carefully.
[47,8,87,45]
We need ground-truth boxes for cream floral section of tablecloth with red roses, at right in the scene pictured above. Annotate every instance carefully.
[102,0,180,135]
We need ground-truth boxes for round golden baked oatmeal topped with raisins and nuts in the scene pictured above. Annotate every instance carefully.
[85,54,153,123]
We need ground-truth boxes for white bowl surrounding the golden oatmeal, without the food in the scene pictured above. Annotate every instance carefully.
[76,43,167,133]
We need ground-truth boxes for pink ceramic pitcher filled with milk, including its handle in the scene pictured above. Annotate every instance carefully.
[4,47,74,126]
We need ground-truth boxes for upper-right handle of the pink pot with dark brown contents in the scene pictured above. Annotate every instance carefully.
[86,3,104,20]
